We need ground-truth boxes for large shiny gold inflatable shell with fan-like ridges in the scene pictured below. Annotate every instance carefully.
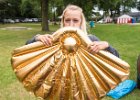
[12,27,129,100]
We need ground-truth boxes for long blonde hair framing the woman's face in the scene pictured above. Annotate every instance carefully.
[61,5,87,34]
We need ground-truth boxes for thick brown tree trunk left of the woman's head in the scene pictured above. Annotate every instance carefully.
[41,0,49,31]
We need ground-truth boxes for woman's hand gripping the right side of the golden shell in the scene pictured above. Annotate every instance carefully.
[88,41,109,53]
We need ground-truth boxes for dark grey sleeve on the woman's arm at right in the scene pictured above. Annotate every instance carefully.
[88,35,119,57]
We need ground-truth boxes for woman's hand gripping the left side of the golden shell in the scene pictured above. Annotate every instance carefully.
[35,34,52,46]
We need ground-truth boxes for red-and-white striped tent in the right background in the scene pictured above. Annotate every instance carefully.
[117,14,132,24]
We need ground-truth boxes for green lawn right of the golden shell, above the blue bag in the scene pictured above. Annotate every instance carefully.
[91,24,140,80]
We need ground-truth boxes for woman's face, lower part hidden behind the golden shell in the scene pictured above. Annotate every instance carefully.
[64,10,82,28]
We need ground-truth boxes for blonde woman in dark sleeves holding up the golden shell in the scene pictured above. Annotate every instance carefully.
[26,5,119,57]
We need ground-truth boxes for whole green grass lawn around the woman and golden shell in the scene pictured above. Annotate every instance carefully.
[0,23,140,100]
